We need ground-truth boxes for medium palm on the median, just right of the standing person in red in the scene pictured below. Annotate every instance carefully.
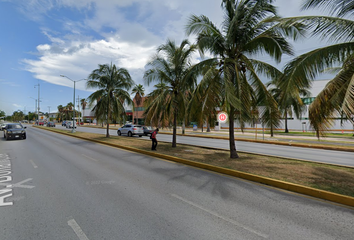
[144,40,196,147]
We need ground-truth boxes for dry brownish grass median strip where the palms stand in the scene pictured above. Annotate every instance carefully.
[39,127,354,197]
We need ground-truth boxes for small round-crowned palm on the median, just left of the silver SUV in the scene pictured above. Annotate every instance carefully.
[86,63,134,137]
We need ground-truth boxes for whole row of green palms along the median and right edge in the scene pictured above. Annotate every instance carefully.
[3,0,354,158]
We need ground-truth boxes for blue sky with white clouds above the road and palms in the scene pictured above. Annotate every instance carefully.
[0,0,327,115]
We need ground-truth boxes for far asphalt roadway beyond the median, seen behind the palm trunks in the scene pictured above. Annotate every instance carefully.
[58,126,354,167]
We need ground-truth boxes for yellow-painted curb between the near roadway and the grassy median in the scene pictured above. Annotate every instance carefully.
[36,126,354,207]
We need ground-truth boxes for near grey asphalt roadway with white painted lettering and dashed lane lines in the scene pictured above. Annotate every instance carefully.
[0,127,354,240]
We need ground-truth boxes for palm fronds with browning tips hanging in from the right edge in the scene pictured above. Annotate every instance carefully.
[283,0,354,138]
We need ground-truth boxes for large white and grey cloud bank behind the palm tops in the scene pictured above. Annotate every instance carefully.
[17,0,334,94]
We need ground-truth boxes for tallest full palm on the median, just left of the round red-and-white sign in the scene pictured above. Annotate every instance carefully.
[186,0,302,158]
